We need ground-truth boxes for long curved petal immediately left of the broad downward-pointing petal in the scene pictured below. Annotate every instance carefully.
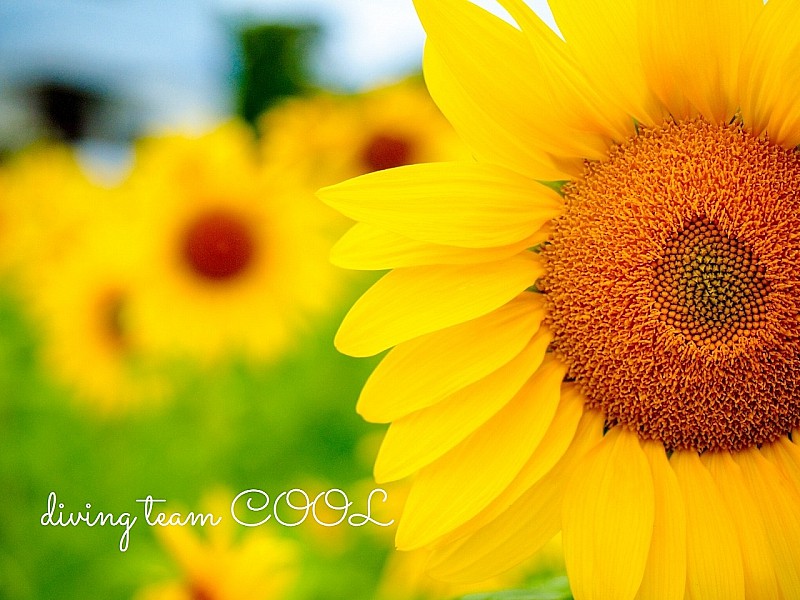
[430,411,605,581]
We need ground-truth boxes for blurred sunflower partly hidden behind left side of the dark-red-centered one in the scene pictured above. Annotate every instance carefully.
[27,205,168,414]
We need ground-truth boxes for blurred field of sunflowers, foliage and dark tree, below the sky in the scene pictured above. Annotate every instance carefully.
[0,2,563,600]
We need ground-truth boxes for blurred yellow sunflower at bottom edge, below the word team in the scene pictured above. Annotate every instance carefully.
[135,495,298,600]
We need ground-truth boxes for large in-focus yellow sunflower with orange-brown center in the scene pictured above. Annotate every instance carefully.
[321,0,800,600]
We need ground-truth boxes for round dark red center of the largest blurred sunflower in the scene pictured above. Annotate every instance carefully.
[183,212,255,281]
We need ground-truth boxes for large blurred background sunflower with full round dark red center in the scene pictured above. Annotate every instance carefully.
[127,123,335,361]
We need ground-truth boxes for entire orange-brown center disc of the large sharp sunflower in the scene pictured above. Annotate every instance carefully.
[541,119,800,451]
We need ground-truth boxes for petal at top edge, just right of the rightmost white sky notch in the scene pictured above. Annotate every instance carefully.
[516,0,662,125]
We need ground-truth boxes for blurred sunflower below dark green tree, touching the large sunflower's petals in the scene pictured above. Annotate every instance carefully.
[260,79,467,189]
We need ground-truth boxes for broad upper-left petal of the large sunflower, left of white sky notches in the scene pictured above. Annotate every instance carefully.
[415,0,627,166]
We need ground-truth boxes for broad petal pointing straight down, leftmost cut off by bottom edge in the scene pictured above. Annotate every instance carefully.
[561,427,655,600]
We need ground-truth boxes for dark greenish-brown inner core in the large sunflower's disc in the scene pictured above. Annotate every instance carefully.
[653,217,767,345]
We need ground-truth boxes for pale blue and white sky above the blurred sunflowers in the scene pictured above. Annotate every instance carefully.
[0,0,549,133]
